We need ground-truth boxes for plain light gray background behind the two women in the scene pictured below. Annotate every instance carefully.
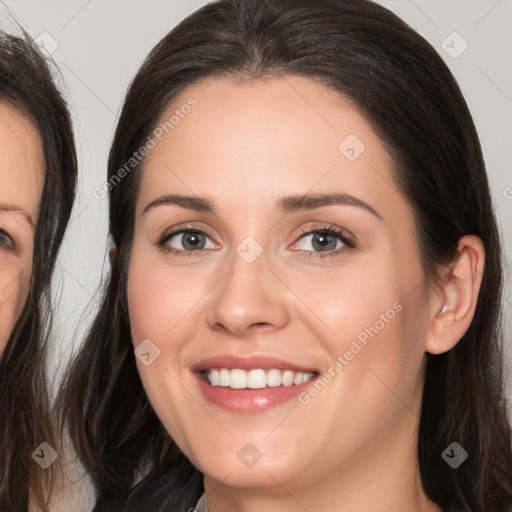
[0,0,512,508]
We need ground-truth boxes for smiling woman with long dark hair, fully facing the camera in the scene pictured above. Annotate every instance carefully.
[61,0,512,512]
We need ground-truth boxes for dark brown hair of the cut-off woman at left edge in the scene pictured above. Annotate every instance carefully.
[0,32,77,512]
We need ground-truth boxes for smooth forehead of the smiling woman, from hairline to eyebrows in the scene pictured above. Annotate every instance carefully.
[138,76,404,220]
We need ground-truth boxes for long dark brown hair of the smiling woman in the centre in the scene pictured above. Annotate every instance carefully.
[61,0,512,512]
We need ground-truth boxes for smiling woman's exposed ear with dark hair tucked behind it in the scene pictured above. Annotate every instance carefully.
[425,235,485,354]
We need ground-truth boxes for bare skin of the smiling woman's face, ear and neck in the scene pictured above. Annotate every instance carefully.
[128,76,484,512]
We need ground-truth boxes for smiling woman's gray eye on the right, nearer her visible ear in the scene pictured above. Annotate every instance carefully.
[294,226,356,258]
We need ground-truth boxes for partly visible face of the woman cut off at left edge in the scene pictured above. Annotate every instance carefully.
[0,103,44,355]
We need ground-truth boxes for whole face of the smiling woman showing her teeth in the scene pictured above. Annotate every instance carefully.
[128,76,436,493]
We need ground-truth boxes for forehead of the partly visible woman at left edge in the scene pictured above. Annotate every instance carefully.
[0,101,44,217]
